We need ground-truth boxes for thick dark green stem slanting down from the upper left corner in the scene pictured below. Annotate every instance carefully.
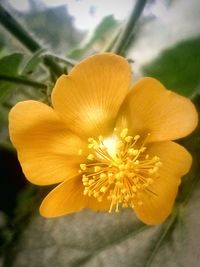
[0,4,63,76]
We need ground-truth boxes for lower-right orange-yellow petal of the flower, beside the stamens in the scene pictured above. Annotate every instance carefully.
[135,141,192,225]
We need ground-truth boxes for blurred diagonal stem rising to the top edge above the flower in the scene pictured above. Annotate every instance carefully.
[113,0,148,55]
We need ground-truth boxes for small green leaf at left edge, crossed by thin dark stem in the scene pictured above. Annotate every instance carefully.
[0,53,23,102]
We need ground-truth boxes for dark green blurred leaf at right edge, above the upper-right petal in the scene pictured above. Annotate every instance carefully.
[142,37,200,96]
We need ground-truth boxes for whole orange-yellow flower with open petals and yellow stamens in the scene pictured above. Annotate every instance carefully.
[9,53,198,224]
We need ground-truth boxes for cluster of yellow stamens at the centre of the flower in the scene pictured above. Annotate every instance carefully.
[79,128,161,212]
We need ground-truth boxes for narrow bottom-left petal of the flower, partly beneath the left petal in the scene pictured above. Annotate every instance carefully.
[40,176,107,218]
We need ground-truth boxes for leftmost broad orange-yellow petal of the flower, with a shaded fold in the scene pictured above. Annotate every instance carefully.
[9,101,86,185]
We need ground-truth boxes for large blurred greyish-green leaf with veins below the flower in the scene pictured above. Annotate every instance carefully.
[4,113,200,267]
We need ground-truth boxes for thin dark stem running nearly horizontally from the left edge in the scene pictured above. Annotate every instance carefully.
[0,74,47,89]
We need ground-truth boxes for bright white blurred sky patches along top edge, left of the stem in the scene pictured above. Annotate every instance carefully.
[7,0,135,30]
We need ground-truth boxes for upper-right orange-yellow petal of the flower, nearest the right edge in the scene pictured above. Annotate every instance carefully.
[118,78,198,142]
